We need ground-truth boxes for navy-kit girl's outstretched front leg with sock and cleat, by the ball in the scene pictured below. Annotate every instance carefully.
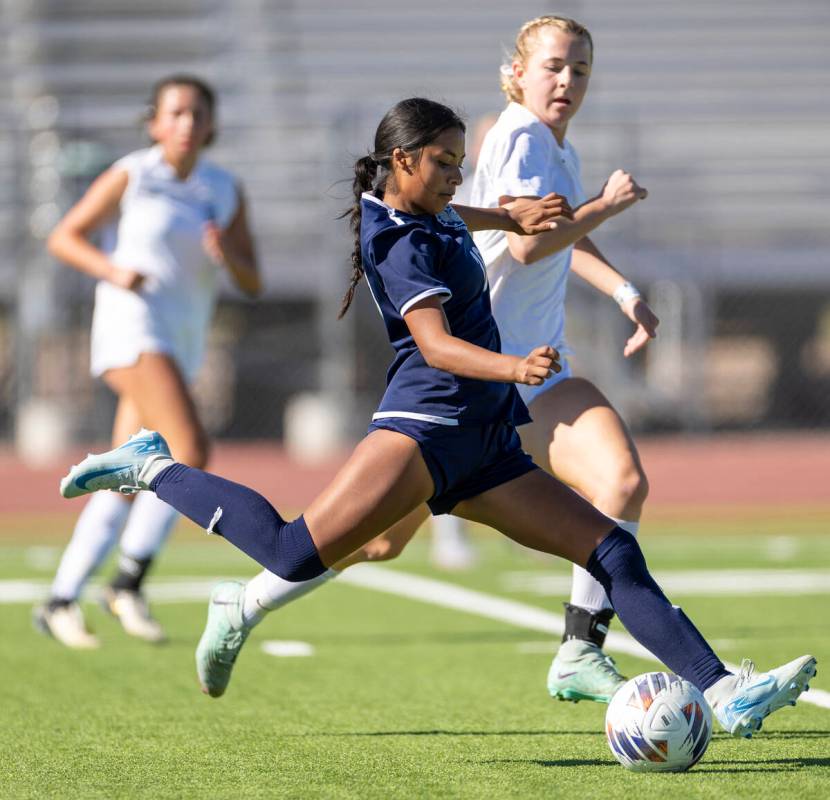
[454,470,816,737]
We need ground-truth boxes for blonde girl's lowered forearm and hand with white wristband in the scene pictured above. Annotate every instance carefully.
[571,236,660,357]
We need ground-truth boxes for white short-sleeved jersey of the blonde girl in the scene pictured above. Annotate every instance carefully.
[471,103,587,402]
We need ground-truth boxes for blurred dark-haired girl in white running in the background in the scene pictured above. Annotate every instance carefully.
[35,75,260,648]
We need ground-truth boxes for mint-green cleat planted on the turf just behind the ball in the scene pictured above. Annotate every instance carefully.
[548,639,625,703]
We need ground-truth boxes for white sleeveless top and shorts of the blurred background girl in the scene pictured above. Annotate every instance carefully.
[90,146,239,381]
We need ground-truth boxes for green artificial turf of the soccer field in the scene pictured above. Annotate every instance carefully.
[0,521,830,800]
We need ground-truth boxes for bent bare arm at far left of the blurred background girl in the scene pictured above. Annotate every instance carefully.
[46,169,144,290]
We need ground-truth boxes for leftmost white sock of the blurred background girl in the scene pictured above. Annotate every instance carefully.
[52,492,130,600]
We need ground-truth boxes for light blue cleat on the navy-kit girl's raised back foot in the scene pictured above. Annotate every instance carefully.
[61,428,172,498]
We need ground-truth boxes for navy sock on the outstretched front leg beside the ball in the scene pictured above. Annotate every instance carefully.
[586,528,729,691]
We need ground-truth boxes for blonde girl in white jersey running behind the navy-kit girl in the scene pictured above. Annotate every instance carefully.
[195,12,657,702]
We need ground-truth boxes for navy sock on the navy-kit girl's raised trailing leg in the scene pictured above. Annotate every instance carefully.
[150,464,326,581]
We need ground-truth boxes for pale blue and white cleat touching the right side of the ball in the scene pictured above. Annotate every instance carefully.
[705,656,816,739]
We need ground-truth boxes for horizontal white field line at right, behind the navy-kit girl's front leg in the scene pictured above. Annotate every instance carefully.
[500,569,830,597]
